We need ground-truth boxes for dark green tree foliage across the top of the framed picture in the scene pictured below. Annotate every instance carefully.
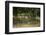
[13,7,40,17]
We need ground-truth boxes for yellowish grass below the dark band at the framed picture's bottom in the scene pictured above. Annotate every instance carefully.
[14,20,40,28]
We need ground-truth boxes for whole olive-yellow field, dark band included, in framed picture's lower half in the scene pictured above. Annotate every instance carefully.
[14,16,40,28]
